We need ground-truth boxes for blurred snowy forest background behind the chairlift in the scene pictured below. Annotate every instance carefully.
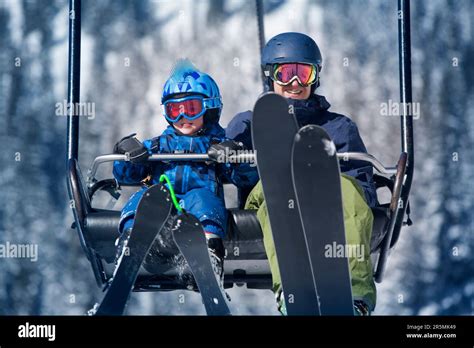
[0,0,474,315]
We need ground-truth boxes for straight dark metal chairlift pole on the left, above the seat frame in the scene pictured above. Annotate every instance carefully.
[67,0,81,160]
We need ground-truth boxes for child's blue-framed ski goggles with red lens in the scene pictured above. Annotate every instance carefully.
[163,95,222,123]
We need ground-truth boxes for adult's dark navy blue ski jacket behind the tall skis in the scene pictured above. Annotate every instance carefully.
[226,95,377,207]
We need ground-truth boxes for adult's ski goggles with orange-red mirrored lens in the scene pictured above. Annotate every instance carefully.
[270,63,319,87]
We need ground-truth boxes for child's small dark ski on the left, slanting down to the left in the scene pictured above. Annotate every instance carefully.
[94,185,172,315]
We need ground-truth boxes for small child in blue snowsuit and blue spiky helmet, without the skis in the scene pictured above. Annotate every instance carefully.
[113,60,256,281]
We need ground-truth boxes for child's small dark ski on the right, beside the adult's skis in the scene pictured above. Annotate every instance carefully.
[172,213,231,315]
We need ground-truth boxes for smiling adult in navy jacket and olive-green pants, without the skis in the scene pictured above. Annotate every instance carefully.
[226,33,377,315]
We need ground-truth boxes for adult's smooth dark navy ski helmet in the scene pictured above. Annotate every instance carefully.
[261,32,323,93]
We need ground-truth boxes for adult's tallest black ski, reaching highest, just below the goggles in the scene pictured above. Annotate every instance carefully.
[252,93,320,315]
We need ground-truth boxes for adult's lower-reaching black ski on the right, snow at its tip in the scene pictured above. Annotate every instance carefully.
[292,125,354,315]
